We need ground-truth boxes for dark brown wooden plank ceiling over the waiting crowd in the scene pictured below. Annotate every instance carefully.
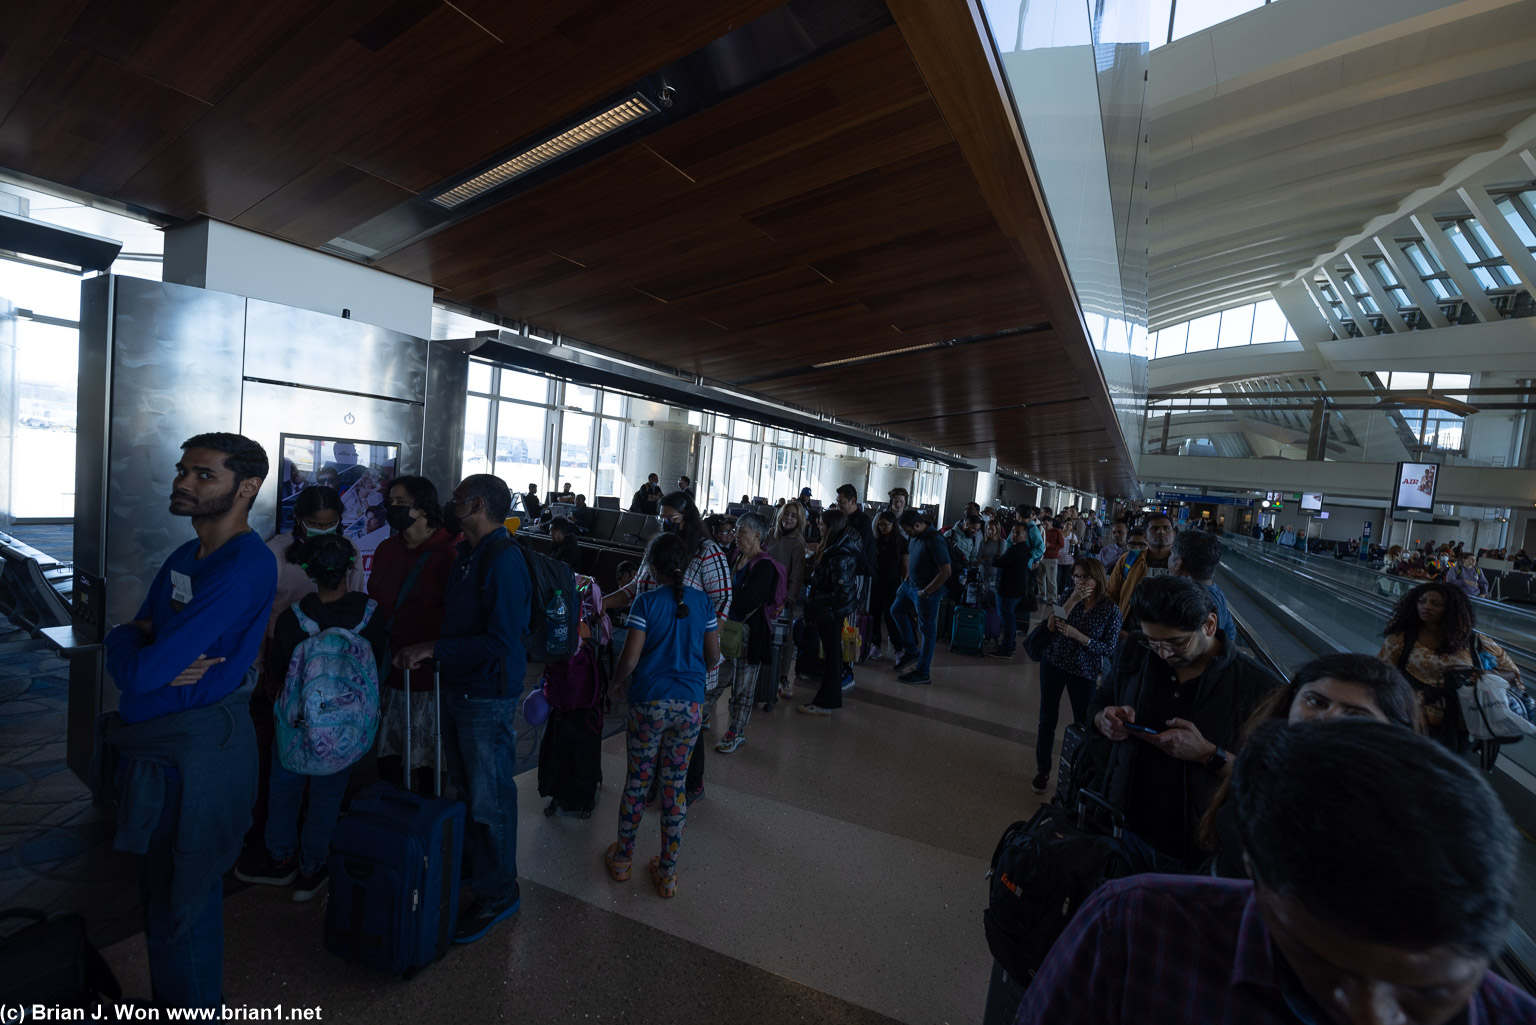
[0,0,1135,493]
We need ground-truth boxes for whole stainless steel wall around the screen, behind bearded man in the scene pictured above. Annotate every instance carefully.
[69,275,442,771]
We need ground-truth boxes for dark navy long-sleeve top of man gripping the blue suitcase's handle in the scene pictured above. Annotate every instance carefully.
[433,527,531,698]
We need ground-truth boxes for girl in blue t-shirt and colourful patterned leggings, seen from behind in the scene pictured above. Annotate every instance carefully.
[602,533,720,897]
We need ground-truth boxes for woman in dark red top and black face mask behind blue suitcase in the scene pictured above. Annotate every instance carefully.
[369,476,458,793]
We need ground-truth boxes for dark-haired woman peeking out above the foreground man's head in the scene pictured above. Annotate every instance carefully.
[1200,652,1422,879]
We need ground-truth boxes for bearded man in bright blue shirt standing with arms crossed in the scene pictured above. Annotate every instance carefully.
[102,433,278,1008]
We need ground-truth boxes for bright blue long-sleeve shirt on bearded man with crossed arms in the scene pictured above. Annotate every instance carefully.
[106,532,278,722]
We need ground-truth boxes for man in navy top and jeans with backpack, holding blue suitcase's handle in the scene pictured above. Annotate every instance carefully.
[395,473,533,944]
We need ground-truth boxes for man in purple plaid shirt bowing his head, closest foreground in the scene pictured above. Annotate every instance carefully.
[1017,718,1536,1025]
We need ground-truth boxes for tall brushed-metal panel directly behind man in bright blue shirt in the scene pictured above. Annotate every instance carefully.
[104,277,245,625]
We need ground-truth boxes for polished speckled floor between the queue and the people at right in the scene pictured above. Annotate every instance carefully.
[108,636,1069,1023]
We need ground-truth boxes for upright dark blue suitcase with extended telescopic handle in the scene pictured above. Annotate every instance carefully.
[326,662,464,977]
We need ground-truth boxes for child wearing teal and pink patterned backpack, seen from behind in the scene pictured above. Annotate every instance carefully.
[235,535,387,901]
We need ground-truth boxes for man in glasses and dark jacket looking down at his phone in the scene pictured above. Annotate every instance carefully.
[1084,576,1283,868]
